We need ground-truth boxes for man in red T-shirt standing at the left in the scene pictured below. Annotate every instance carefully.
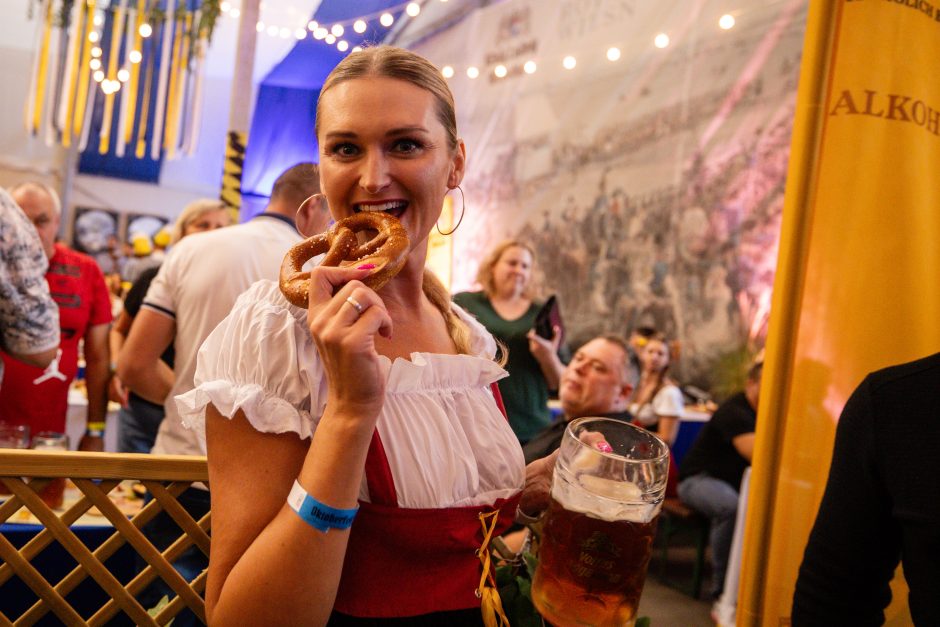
[0,183,111,451]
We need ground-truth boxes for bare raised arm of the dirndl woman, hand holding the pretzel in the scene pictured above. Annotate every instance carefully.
[208,266,391,625]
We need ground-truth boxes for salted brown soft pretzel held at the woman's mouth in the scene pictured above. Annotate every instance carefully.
[279,211,409,308]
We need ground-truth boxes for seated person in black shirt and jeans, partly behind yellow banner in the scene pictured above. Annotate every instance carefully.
[679,362,763,599]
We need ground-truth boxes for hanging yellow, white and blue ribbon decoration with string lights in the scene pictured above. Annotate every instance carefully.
[25,0,221,160]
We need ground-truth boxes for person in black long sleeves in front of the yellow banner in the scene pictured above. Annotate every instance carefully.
[792,353,940,627]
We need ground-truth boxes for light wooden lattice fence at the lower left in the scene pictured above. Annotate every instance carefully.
[0,449,210,625]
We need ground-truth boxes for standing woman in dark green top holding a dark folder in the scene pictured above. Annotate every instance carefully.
[454,240,565,444]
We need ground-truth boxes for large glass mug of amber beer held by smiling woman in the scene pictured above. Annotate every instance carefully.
[532,417,669,627]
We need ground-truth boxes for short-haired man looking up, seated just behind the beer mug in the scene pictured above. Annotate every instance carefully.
[522,335,638,464]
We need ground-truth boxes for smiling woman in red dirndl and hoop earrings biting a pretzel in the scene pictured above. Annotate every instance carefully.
[177,46,551,625]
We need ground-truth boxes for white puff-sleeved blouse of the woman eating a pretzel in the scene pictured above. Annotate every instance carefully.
[176,281,525,508]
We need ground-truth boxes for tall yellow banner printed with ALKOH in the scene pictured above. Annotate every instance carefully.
[738,0,940,627]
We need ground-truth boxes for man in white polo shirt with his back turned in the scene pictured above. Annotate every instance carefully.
[117,163,330,625]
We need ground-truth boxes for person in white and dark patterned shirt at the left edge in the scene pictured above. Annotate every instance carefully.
[0,189,59,384]
